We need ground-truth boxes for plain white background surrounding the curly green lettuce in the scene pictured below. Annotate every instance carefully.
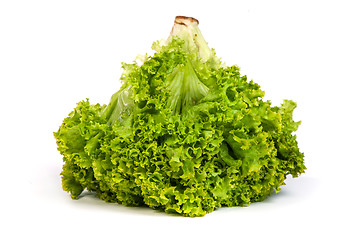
[0,0,360,239]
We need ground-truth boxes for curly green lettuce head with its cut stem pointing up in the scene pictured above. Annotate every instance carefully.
[54,17,305,217]
